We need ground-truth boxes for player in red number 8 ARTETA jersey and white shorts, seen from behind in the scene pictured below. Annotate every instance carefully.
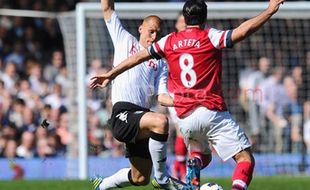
[91,0,284,190]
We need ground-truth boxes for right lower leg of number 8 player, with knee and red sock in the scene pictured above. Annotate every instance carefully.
[232,148,255,190]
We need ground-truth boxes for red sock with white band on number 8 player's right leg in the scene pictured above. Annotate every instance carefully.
[232,161,254,190]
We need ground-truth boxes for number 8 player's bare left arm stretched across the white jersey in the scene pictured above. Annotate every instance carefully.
[89,49,151,89]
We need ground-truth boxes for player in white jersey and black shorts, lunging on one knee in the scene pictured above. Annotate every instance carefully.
[92,0,182,190]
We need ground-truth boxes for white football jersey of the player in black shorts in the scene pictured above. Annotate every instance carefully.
[106,12,168,108]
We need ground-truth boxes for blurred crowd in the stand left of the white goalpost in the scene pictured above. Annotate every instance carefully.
[0,0,85,158]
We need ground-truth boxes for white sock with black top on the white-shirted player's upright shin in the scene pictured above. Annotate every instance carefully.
[149,133,168,184]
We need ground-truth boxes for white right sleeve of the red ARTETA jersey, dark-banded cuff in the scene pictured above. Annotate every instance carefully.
[208,28,233,49]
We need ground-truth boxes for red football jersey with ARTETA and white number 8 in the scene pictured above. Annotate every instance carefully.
[148,28,232,117]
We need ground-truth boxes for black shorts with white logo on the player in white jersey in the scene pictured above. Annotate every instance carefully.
[111,102,151,159]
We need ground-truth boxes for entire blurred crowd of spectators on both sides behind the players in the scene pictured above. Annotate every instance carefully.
[0,0,310,161]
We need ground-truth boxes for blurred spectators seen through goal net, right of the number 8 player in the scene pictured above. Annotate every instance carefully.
[239,55,310,153]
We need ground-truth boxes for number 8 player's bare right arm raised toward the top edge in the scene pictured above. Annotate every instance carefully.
[231,0,284,44]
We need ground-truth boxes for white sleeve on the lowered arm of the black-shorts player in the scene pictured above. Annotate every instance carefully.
[154,59,168,95]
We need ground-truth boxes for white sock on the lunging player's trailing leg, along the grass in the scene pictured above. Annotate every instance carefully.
[99,168,134,190]
